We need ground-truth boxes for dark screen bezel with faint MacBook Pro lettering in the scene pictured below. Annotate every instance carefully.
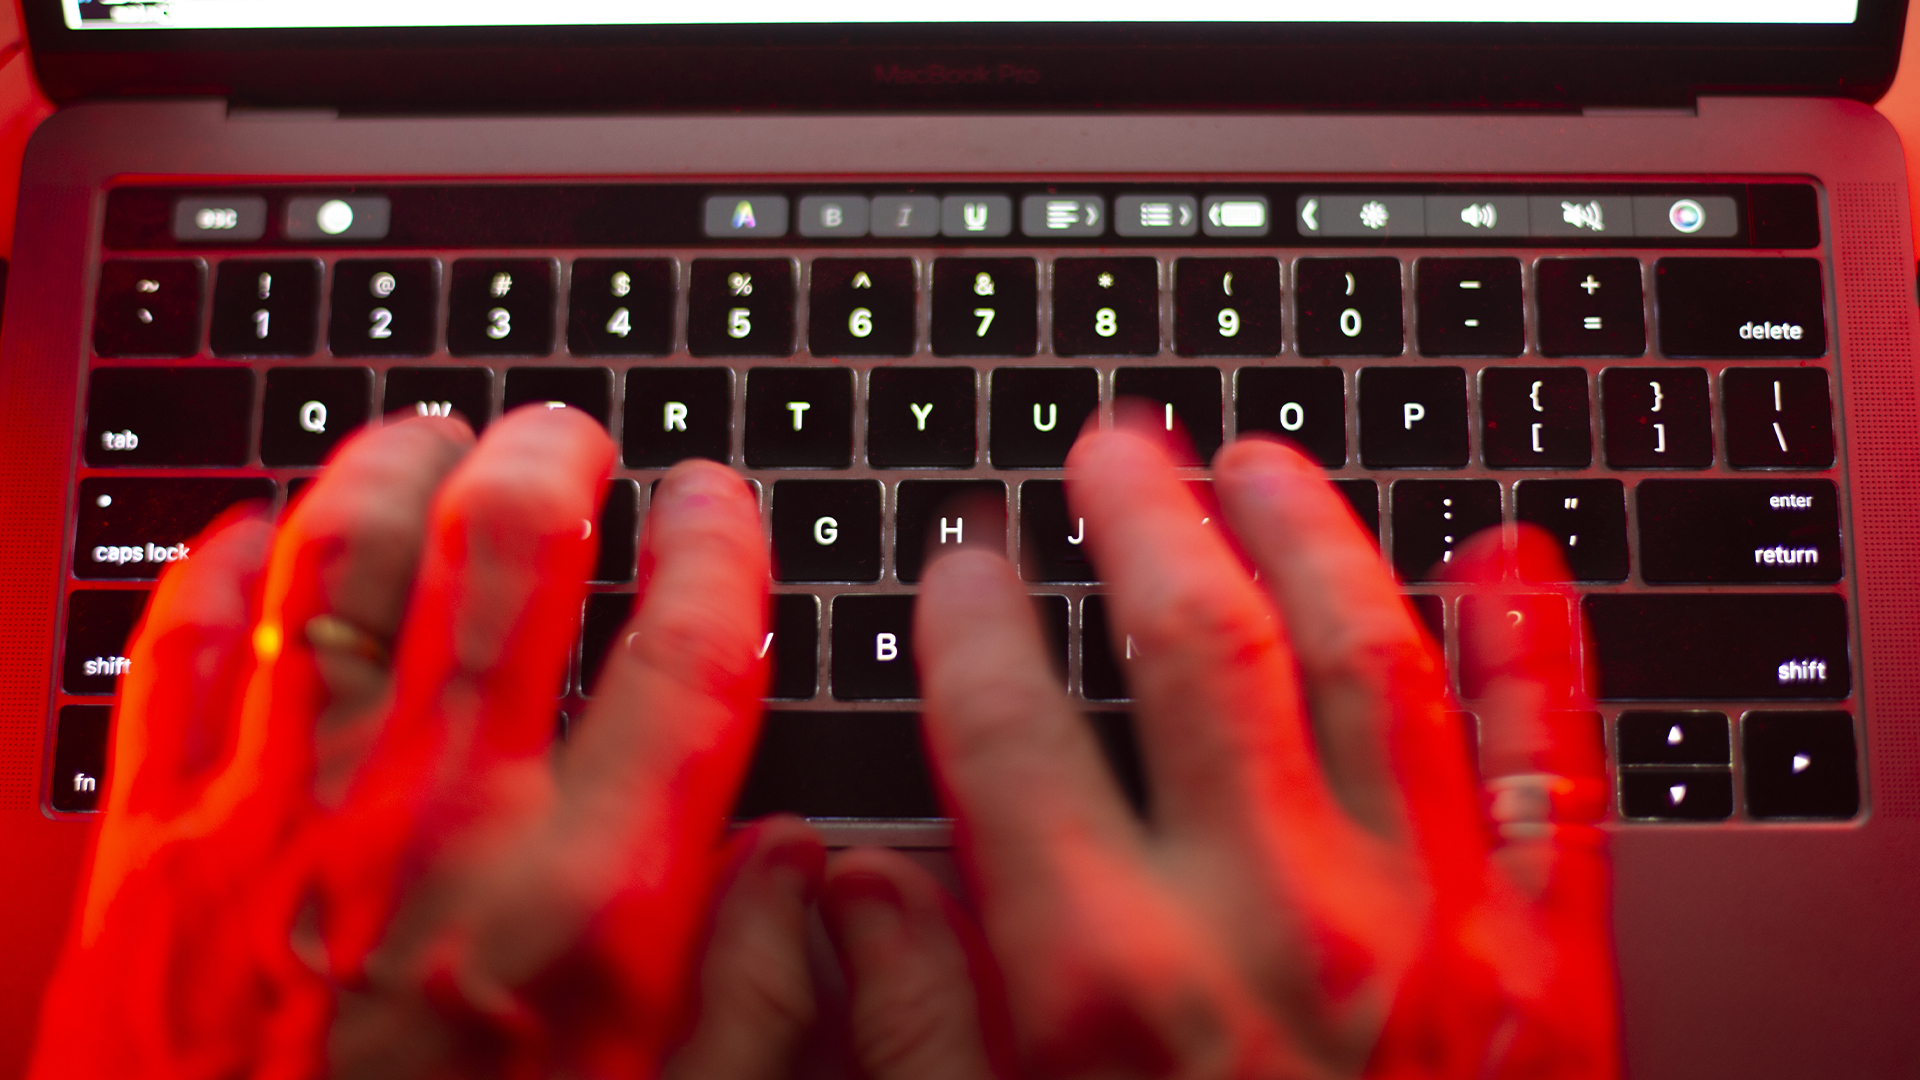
[23,0,1907,113]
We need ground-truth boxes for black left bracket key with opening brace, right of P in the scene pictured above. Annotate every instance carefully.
[1480,367,1594,469]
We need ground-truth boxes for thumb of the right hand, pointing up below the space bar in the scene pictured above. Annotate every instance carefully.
[820,847,996,1080]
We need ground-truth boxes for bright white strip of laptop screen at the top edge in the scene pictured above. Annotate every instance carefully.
[61,0,1859,29]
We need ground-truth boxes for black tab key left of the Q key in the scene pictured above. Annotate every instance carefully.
[86,367,253,469]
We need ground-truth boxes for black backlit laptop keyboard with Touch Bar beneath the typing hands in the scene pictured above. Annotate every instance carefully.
[46,183,1860,824]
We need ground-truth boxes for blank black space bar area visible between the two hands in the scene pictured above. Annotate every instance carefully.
[733,711,943,821]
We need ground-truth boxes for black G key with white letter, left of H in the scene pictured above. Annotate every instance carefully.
[774,480,881,582]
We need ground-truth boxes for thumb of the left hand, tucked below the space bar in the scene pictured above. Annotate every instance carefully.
[662,817,826,1080]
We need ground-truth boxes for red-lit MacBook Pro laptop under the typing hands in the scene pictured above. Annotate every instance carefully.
[0,0,1920,1080]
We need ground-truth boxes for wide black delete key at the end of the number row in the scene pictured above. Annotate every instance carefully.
[1653,258,1826,357]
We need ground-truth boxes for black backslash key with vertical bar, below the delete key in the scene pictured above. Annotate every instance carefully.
[1720,367,1834,469]
